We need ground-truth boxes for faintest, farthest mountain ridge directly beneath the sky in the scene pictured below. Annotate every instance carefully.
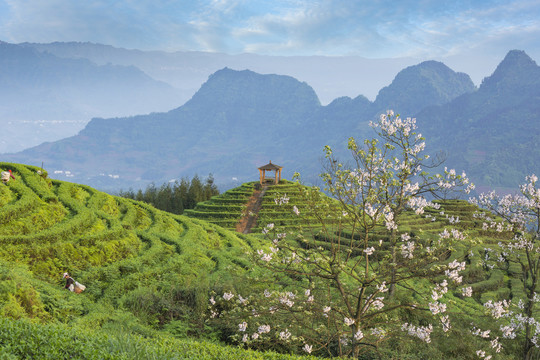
[20,42,418,105]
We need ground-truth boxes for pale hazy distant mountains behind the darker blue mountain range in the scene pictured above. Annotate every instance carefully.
[0,41,417,153]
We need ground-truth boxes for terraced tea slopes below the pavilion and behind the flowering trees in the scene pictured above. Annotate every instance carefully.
[186,180,523,305]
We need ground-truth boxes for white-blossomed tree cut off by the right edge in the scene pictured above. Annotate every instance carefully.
[471,175,540,359]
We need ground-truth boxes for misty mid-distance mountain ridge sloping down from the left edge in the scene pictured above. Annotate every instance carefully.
[0,42,185,152]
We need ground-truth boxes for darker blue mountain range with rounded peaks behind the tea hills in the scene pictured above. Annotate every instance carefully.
[3,50,540,194]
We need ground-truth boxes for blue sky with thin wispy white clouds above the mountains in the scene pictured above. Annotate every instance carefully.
[0,0,540,82]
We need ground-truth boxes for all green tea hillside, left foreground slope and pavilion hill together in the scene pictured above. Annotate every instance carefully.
[0,163,523,359]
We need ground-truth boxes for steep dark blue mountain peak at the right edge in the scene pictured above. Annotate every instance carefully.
[416,50,540,189]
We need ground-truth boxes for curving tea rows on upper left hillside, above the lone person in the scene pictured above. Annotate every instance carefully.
[0,163,258,281]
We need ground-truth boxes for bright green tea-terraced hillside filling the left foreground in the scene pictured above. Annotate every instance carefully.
[0,163,324,359]
